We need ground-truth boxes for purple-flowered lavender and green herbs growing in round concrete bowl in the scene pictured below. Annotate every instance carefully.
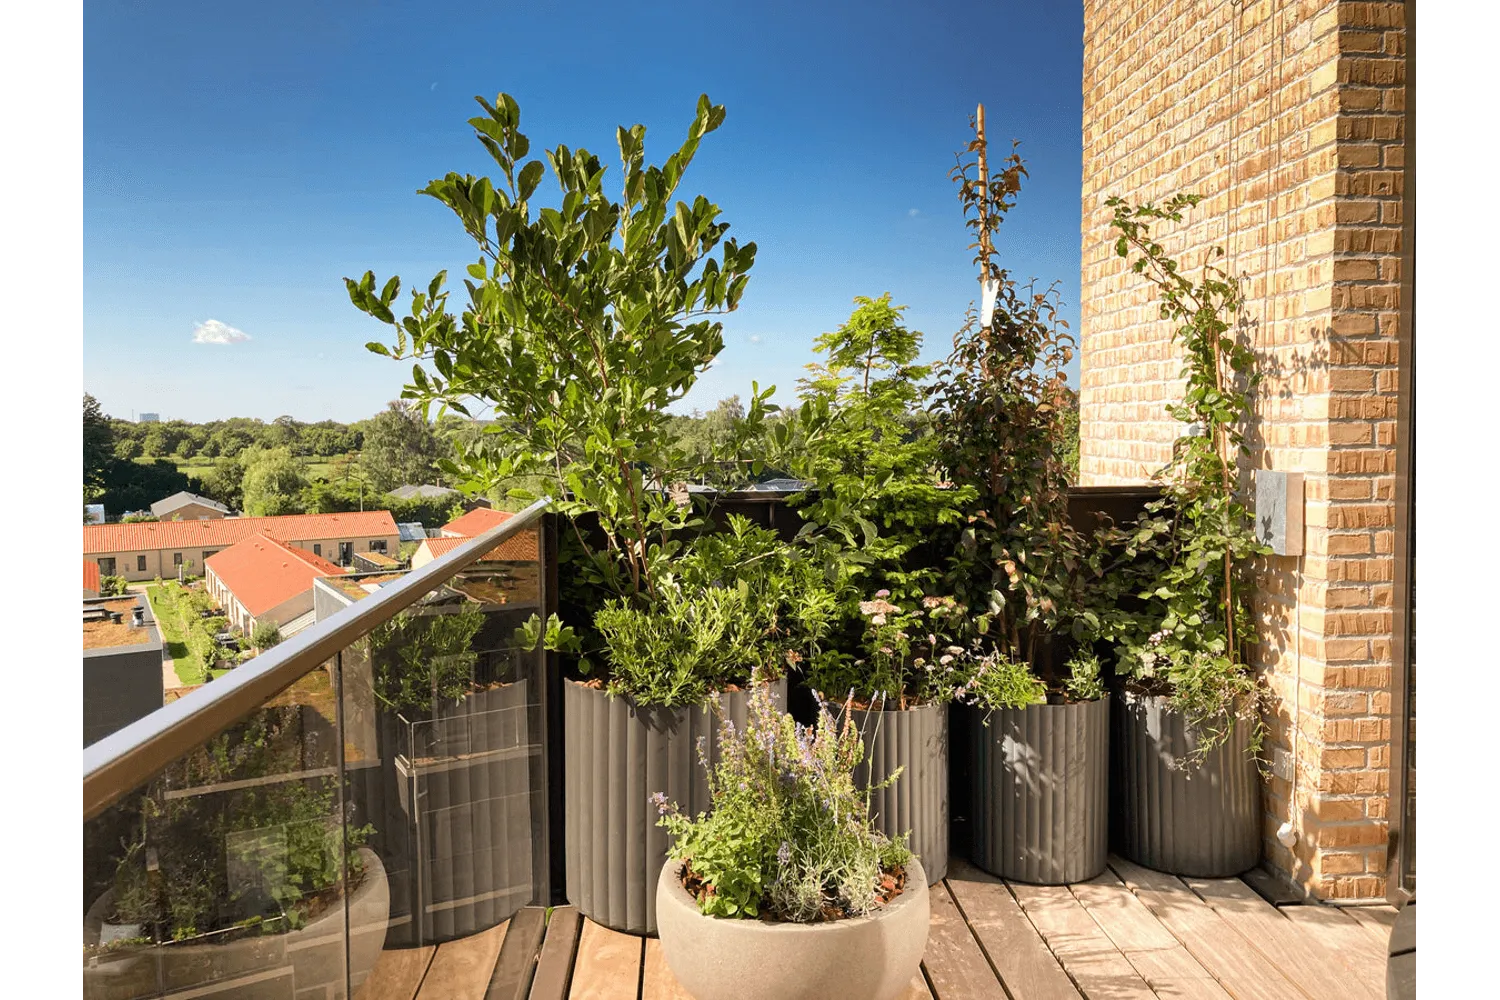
[651,685,912,922]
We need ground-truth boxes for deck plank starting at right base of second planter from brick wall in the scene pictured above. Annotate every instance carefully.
[1070,871,1230,1000]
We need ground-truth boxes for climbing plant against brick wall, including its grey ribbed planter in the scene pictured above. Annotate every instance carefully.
[1100,195,1269,877]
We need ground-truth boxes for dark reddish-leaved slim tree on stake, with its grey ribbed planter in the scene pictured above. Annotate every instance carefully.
[929,108,1109,885]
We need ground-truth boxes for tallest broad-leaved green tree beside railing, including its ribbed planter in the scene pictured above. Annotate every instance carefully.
[347,94,812,933]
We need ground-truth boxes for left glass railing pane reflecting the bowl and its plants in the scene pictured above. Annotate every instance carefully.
[80,664,354,1000]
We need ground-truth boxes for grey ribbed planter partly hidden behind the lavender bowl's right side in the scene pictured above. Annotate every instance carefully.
[854,705,948,885]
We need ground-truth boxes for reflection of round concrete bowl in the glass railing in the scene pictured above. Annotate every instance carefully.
[80,847,390,1000]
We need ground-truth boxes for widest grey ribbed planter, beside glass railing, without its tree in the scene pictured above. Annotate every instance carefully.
[563,679,786,934]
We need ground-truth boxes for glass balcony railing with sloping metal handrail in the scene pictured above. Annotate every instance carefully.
[80,501,551,1000]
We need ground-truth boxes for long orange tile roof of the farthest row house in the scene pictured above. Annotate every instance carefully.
[81,510,399,555]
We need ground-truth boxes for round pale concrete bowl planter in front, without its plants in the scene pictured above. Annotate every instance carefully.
[657,861,930,1000]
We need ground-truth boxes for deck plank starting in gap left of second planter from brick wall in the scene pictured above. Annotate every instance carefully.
[947,859,1083,1000]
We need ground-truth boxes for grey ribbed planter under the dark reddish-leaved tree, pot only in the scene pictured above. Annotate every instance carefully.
[968,696,1110,885]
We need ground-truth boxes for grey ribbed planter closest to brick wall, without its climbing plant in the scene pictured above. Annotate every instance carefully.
[1110,691,1262,879]
